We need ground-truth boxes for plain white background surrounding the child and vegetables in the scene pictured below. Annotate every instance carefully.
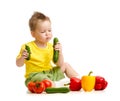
[0,0,120,101]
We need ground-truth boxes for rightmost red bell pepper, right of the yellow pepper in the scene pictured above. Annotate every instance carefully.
[94,76,108,90]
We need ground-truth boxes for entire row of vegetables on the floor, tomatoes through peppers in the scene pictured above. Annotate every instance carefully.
[27,72,108,94]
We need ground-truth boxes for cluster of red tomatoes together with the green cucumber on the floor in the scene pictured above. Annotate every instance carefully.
[27,79,70,94]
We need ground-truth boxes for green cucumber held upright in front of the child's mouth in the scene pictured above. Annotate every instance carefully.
[53,37,59,63]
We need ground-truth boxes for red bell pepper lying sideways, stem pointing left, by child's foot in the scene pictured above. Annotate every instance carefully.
[64,77,81,91]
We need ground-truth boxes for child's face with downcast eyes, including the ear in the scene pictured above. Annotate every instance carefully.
[32,20,52,44]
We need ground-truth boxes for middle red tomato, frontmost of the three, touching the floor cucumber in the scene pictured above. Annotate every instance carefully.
[33,81,45,93]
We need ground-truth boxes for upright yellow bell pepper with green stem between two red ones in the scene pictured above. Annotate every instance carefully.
[81,71,95,92]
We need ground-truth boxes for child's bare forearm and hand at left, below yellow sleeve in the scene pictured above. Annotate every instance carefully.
[16,50,28,67]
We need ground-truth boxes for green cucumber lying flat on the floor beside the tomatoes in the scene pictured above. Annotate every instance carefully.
[45,87,70,93]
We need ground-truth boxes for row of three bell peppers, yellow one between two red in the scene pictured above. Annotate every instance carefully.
[64,71,108,92]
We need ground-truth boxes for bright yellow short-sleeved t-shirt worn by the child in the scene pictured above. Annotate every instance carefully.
[17,41,53,78]
